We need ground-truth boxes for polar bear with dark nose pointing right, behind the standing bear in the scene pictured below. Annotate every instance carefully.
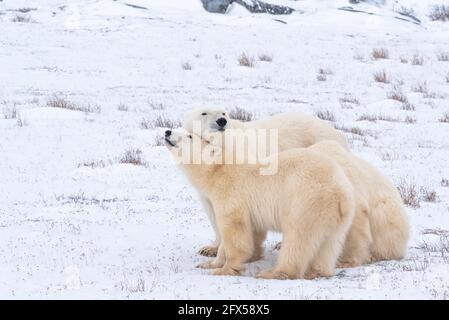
[183,108,349,257]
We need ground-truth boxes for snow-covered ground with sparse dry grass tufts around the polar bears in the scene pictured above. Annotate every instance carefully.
[0,0,449,299]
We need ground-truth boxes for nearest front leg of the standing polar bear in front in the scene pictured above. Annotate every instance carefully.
[212,210,254,276]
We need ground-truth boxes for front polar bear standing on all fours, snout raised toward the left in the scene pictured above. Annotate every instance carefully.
[165,131,355,279]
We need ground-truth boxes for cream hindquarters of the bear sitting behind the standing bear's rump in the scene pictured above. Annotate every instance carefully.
[308,141,409,267]
